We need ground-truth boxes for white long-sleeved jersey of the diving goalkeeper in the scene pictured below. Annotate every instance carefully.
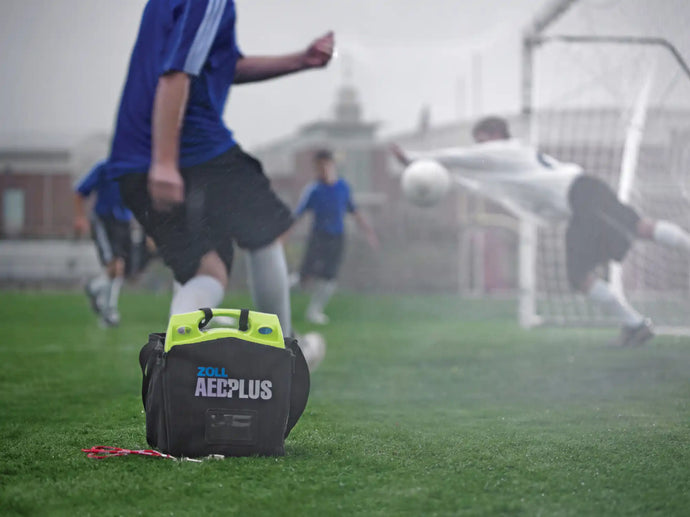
[411,139,582,224]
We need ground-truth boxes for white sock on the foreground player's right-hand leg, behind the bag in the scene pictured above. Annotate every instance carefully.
[247,242,292,336]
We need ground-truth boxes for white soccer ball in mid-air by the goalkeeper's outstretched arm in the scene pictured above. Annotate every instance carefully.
[401,160,450,207]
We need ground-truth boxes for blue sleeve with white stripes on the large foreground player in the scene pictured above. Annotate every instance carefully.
[161,0,228,75]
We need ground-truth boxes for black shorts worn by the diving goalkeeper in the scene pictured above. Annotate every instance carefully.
[565,174,640,289]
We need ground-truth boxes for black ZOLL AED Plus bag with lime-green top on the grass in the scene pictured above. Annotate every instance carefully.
[139,309,309,457]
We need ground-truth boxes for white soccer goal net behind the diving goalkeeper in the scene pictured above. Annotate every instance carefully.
[520,0,690,334]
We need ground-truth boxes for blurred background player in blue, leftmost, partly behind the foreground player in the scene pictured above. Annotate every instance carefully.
[74,162,132,327]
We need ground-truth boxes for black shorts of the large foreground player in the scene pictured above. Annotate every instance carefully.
[120,146,292,283]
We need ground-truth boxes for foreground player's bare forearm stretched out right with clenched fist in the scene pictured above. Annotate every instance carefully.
[234,32,335,84]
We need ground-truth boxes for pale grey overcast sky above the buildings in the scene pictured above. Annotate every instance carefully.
[0,0,690,147]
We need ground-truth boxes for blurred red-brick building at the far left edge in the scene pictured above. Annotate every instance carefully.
[0,134,109,286]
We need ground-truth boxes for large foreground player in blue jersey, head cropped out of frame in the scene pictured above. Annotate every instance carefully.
[103,0,334,340]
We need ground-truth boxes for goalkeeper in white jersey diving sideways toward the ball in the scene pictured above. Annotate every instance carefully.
[392,117,690,346]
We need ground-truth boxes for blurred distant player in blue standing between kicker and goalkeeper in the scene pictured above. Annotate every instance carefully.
[288,149,379,325]
